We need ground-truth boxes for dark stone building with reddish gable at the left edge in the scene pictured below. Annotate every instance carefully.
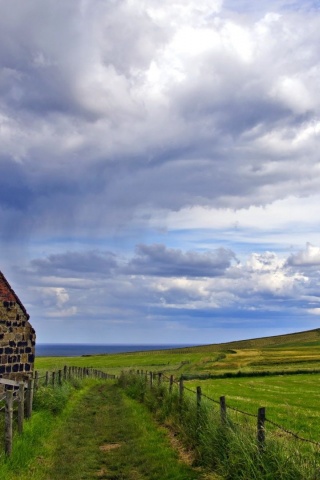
[0,272,36,380]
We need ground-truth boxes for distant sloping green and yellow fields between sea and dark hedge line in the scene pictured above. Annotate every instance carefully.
[35,329,320,376]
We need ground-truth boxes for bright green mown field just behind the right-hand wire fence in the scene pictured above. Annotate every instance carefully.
[185,374,320,442]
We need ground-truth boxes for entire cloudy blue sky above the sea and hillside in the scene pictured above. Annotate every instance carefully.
[0,0,320,344]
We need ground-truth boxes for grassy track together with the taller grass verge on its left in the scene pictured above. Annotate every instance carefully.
[0,379,211,480]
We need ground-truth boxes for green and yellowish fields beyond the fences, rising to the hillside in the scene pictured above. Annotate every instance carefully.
[36,329,320,441]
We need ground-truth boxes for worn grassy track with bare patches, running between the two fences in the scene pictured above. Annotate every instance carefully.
[37,384,213,480]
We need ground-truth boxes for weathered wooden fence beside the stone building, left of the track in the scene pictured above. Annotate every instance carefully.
[0,366,116,456]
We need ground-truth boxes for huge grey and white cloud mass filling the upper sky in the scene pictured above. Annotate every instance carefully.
[0,0,320,240]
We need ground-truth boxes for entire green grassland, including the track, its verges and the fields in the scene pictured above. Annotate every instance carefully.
[0,329,320,480]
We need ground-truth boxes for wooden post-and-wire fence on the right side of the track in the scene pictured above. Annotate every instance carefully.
[127,370,320,451]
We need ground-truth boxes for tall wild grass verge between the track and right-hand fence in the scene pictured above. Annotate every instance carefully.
[119,373,320,480]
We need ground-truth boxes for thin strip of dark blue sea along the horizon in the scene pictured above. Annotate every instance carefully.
[36,343,192,357]
